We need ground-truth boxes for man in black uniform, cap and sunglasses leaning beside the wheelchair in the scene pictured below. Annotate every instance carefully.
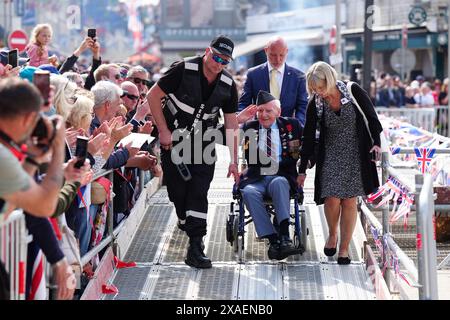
[147,35,239,268]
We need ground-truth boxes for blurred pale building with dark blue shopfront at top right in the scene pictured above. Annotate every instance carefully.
[342,0,448,80]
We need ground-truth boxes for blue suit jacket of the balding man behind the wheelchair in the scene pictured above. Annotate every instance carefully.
[239,62,308,127]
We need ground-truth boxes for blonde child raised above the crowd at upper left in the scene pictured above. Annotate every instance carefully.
[25,24,58,67]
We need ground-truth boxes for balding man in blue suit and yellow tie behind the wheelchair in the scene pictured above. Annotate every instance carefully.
[238,37,308,127]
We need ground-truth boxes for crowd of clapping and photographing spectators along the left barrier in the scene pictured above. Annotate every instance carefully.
[0,24,162,299]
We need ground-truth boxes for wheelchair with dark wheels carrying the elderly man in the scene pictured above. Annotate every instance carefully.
[226,184,309,263]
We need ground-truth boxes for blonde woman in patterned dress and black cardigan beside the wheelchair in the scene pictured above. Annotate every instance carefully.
[299,62,382,264]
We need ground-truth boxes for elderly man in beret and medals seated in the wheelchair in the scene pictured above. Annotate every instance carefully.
[239,91,302,260]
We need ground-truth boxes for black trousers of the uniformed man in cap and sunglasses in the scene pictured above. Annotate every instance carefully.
[161,150,215,237]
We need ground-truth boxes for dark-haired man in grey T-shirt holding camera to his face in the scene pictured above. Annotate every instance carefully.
[0,78,65,217]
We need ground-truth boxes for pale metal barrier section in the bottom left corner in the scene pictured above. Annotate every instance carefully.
[0,210,32,300]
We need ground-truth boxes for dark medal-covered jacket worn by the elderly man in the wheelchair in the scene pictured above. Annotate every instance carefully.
[239,117,302,190]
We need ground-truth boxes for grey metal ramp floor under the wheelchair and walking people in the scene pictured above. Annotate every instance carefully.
[101,148,376,300]
